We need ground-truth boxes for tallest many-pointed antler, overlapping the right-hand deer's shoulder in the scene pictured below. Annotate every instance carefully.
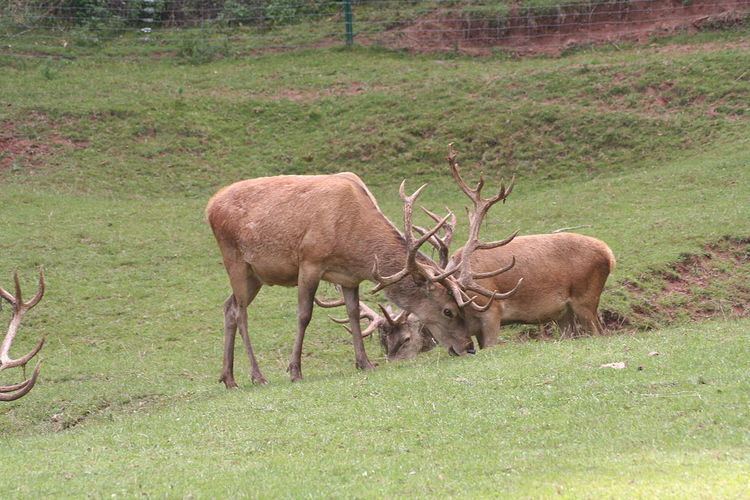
[445,143,523,311]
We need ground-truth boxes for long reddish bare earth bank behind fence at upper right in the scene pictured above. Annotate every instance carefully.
[370,0,750,55]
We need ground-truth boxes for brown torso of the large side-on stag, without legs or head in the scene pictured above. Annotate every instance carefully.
[206,173,402,286]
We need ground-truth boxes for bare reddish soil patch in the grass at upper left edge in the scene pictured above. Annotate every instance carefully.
[0,113,88,172]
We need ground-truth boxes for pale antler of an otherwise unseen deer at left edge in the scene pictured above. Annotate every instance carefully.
[0,270,44,401]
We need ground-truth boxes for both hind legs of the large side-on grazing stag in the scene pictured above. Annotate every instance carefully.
[220,262,268,389]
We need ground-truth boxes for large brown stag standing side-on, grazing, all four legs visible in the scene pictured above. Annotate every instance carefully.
[206,158,518,388]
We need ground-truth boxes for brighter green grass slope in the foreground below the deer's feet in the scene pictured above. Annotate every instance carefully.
[0,321,750,497]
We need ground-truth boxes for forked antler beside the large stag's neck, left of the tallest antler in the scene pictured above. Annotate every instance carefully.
[371,180,455,293]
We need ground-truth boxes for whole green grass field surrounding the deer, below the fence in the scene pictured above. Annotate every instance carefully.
[0,25,750,498]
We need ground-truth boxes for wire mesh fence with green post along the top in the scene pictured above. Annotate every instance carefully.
[0,0,750,60]
